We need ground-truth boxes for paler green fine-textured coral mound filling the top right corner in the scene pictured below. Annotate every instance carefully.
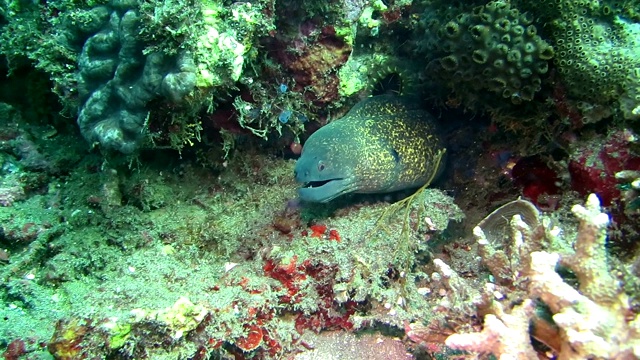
[518,0,640,109]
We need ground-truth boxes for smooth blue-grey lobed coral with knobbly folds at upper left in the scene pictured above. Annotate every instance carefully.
[77,1,196,154]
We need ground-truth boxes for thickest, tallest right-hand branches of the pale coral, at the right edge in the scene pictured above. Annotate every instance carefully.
[530,195,640,359]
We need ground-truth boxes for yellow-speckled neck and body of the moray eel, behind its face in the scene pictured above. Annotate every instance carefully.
[323,95,445,193]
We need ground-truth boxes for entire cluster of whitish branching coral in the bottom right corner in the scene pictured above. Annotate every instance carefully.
[446,194,640,360]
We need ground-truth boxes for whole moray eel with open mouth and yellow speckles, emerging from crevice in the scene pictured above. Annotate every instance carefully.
[294,95,445,203]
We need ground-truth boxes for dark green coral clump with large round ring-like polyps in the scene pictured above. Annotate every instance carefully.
[438,0,554,106]
